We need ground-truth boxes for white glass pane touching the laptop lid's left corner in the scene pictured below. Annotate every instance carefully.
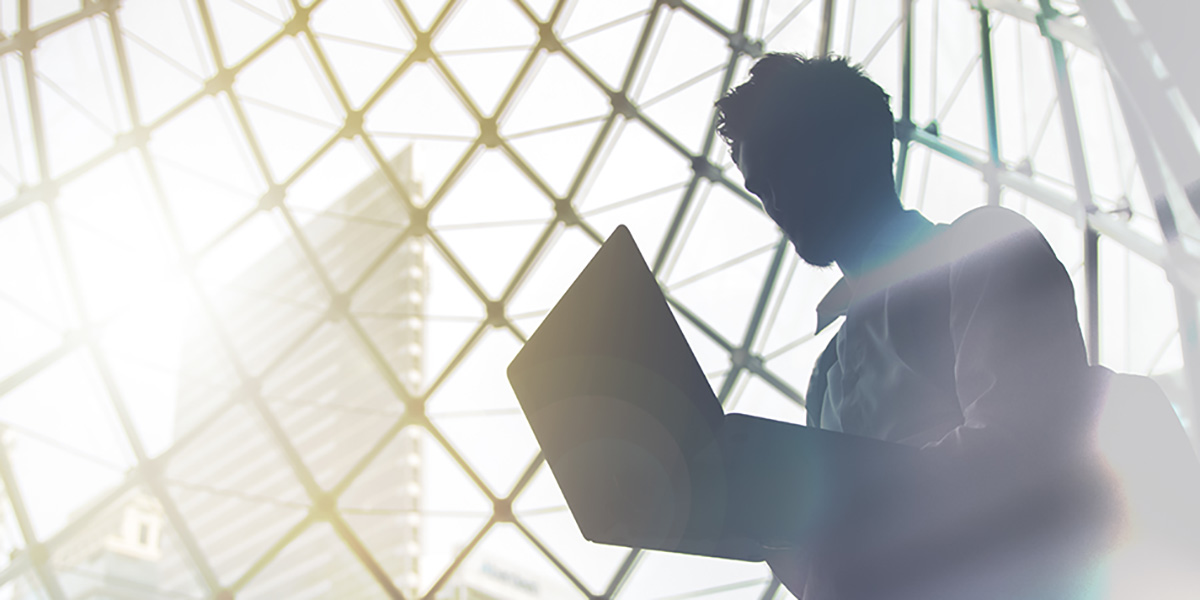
[426,330,538,497]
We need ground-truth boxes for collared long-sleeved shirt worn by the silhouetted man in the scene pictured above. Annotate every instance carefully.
[787,208,1105,600]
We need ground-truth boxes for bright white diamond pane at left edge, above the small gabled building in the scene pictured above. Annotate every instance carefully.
[0,350,134,539]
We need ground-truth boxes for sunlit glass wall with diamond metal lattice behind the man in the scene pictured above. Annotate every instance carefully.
[0,0,1200,600]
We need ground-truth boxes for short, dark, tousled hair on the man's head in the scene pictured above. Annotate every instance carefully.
[716,53,894,176]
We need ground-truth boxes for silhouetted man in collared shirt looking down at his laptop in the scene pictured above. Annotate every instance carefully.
[718,54,1111,600]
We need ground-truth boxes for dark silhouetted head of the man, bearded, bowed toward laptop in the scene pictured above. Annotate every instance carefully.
[716,54,896,266]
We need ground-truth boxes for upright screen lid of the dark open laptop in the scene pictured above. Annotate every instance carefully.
[508,226,726,553]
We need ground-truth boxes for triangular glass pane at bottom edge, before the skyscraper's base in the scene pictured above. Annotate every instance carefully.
[238,522,384,600]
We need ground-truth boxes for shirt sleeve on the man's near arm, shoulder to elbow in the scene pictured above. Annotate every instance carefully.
[925,208,1092,486]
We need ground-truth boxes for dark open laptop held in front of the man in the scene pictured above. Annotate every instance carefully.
[508,226,917,560]
